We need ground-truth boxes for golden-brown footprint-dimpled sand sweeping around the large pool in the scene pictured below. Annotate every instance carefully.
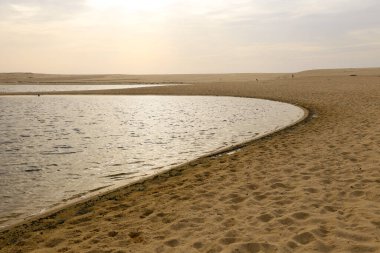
[0,69,380,253]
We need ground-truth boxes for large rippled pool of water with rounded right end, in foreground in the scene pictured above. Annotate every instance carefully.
[0,96,303,226]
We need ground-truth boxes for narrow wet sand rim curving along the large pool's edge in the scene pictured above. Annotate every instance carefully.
[0,96,309,233]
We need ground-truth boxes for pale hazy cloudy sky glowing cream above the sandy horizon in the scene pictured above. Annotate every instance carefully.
[0,0,380,74]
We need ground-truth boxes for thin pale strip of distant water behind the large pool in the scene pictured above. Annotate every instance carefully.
[0,84,168,92]
